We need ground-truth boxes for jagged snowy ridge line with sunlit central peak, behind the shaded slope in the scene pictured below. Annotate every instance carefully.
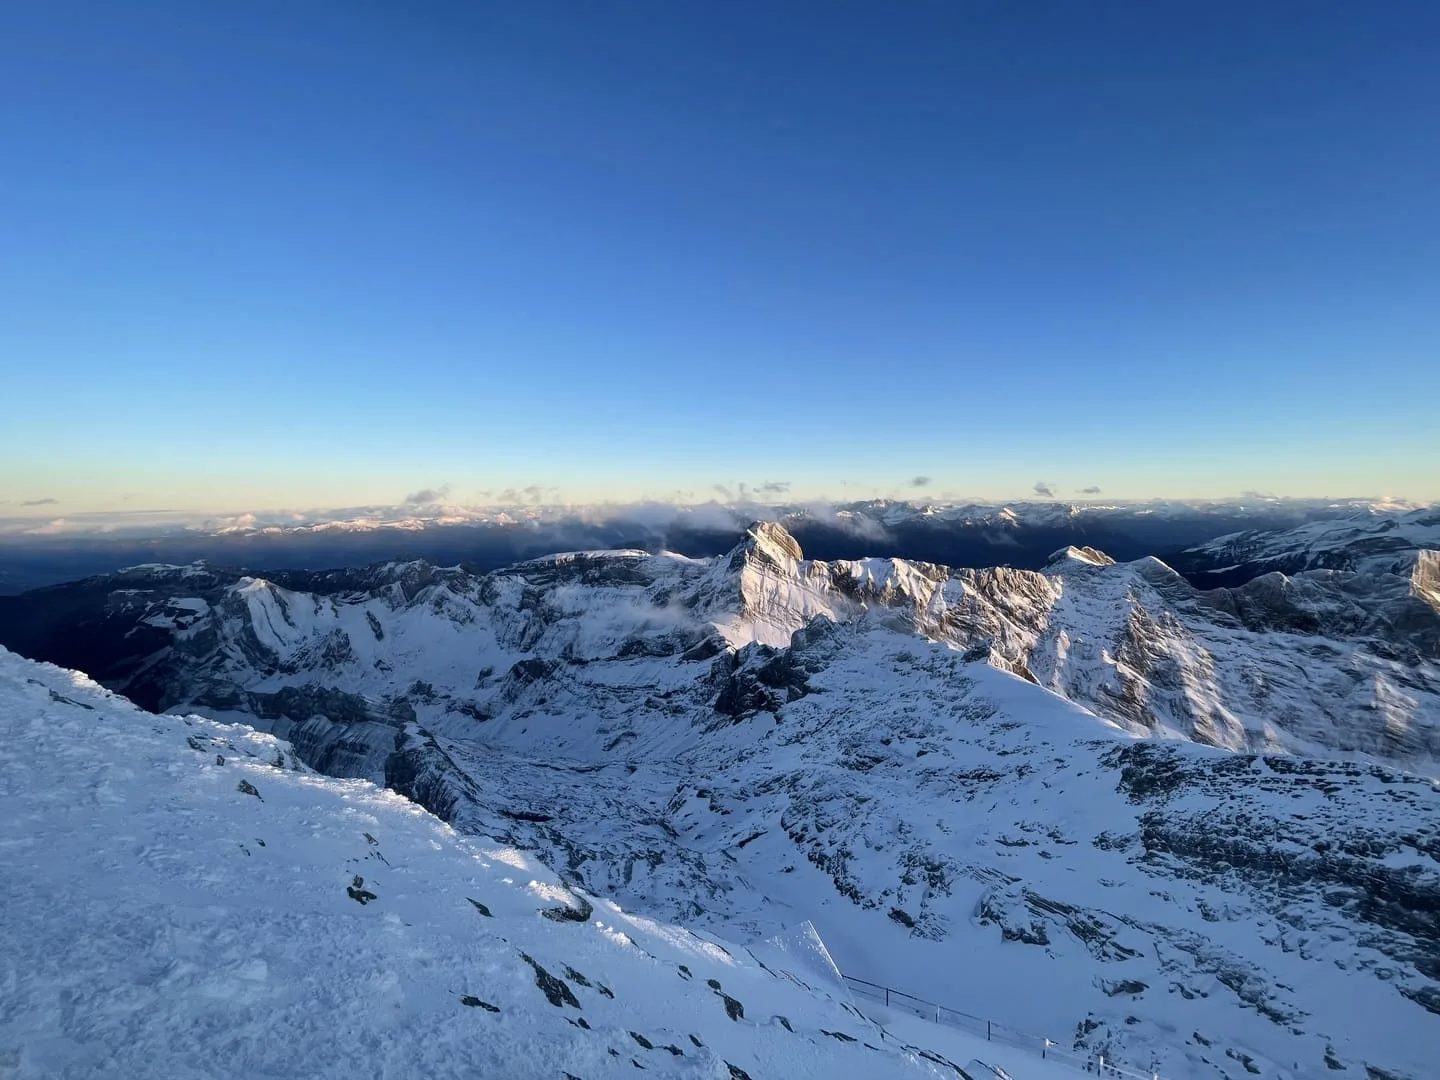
[36,523,1440,775]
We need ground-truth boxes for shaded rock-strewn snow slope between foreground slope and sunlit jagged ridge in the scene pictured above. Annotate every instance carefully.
[418,633,1440,1080]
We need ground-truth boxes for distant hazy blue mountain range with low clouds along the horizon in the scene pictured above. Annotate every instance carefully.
[0,495,1417,595]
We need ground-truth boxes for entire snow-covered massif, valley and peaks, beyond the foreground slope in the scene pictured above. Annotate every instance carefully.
[5,524,1440,1080]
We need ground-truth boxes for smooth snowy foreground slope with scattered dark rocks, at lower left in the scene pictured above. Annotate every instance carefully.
[0,651,1013,1080]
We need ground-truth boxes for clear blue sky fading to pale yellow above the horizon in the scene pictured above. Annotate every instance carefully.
[0,0,1440,514]
